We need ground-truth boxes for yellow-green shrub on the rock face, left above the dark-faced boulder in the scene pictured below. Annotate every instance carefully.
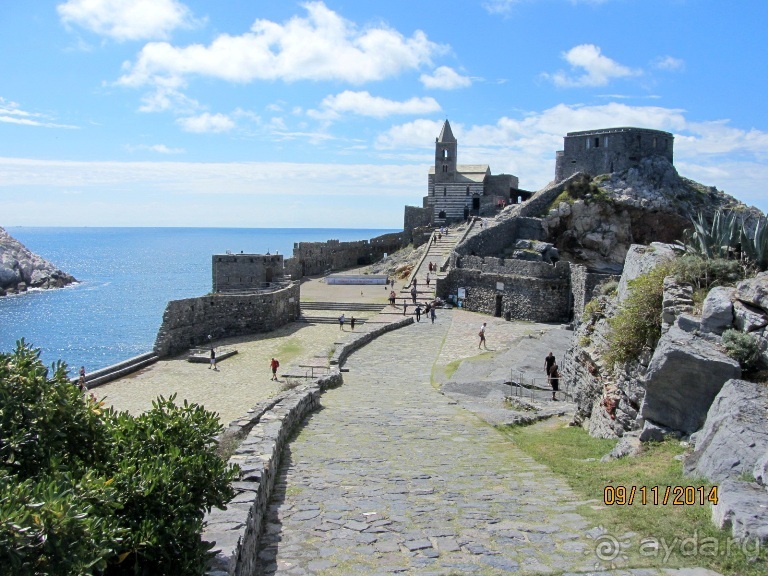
[605,262,671,365]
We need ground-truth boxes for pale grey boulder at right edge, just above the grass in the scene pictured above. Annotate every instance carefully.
[685,380,768,482]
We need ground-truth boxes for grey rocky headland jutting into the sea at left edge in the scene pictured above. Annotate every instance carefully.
[0,228,77,296]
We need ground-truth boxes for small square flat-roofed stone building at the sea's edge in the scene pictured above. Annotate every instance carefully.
[211,254,285,293]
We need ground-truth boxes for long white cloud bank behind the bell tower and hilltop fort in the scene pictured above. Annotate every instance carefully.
[376,102,768,211]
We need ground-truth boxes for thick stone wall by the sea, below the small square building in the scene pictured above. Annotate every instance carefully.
[154,282,300,357]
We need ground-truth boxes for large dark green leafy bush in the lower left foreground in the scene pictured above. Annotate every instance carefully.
[0,340,237,576]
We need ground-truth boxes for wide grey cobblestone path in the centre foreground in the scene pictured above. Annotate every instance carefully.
[261,313,612,575]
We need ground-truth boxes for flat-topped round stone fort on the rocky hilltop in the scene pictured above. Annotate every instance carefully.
[555,128,675,182]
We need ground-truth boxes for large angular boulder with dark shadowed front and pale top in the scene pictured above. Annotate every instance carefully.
[640,326,741,434]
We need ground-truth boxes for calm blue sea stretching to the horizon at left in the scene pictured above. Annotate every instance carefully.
[0,227,395,371]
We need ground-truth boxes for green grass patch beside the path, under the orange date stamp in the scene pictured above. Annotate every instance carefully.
[502,423,768,576]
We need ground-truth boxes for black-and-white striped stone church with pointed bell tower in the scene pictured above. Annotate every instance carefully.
[424,120,530,225]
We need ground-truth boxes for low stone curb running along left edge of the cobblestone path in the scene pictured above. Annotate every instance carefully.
[202,317,414,576]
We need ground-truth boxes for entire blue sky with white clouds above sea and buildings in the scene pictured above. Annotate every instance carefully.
[0,0,768,228]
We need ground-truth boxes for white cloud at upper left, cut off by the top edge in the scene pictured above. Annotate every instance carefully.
[56,0,197,42]
